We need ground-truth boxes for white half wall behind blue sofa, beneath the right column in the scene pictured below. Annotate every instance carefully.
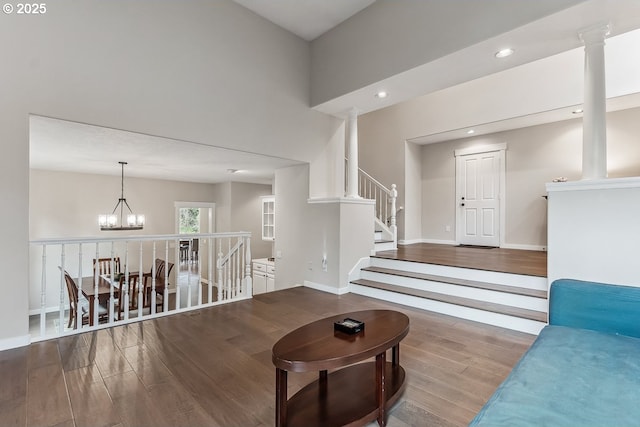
[547,178,640,286]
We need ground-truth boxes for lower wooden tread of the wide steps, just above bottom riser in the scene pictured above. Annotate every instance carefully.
[351,279,547,323]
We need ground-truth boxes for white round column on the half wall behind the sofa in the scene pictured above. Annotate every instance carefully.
[580,25,609,179]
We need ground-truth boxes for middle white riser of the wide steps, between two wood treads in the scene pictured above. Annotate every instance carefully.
[361,271,548,313]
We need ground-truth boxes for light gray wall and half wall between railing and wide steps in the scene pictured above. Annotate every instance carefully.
[274,165,374,293]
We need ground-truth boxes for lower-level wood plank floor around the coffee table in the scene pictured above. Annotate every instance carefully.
[5,287,535,427]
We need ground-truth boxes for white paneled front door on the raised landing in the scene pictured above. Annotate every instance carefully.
[456,146,504,247]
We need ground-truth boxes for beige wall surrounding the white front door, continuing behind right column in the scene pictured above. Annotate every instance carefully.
[422,108,640,249]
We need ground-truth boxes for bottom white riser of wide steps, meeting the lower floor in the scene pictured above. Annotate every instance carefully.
[350,283,546,335]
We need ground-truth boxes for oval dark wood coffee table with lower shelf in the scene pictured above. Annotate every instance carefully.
[272,310,409,427]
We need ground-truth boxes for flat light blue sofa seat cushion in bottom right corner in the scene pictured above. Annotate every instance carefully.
[470,325,640,427]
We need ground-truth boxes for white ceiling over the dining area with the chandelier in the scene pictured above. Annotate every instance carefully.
[29,115,306,184]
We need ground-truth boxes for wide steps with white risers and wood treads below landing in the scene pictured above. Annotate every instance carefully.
[350,256,548,335]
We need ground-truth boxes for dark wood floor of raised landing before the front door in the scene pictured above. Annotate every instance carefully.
[376,243,547,277]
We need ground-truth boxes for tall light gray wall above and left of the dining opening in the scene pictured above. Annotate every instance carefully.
[0,0,341,348]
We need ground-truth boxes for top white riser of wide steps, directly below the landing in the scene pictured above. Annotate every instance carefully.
[371,257,548,291]
